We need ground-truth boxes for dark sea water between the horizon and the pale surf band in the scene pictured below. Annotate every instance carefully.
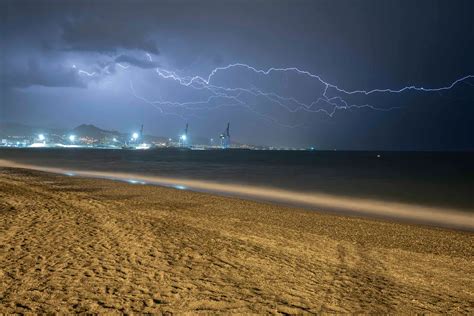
[0,148,474,212]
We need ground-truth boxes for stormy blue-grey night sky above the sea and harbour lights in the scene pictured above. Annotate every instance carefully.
[0,0,474,150]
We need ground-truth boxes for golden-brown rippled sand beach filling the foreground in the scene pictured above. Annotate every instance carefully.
[0,168,474,314]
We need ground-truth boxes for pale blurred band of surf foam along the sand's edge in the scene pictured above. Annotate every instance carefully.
[0,159,474,231]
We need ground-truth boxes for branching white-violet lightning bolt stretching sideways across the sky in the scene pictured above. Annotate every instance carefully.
[73,53,474,127]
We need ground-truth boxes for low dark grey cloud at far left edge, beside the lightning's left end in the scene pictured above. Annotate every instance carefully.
[3,59,86,88]
